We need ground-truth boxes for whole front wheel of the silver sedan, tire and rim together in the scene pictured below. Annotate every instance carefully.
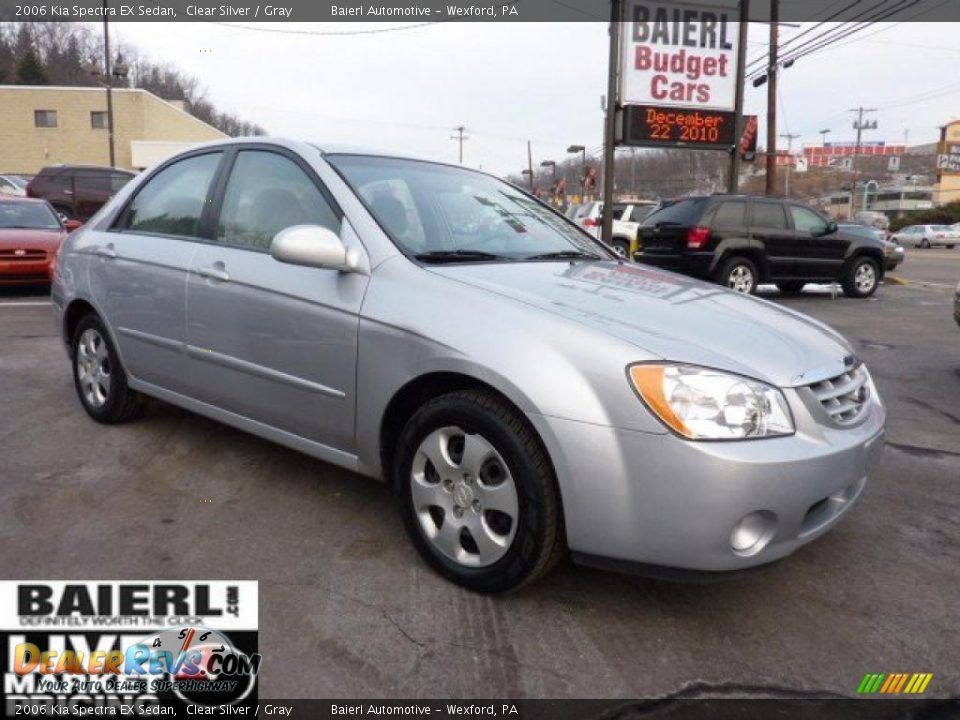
[393,390,566,592]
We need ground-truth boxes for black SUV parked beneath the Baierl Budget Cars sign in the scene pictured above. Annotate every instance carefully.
[634,194,885,298]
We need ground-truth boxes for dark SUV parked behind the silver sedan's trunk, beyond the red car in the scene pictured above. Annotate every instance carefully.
[27,165,135,221]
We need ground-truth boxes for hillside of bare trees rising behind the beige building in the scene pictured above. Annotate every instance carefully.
[0,22,265,137]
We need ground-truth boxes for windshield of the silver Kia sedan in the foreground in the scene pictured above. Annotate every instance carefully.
[326,155,611,261]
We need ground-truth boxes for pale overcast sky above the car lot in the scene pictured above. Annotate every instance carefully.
[111,22,960,175]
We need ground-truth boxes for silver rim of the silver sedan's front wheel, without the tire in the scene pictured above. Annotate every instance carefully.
[410,426,520,567]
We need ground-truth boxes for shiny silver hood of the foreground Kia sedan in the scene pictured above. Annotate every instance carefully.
[429,261,852,387]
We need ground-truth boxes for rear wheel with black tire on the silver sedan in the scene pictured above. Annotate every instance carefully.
[70,313,146,425]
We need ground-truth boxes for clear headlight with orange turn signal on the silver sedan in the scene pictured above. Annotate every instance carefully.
[628,364,794,440]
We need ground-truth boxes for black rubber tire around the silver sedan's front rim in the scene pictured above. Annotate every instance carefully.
[391,389,567,593]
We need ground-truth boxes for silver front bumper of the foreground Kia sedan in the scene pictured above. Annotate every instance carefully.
[530,392,885,572]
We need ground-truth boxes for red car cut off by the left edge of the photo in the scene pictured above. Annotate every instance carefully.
[0,195,80,285]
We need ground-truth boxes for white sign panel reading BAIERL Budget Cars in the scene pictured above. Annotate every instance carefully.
[620,0,740,110]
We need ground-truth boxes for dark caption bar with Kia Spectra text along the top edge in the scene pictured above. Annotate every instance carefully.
[0,0,960,22]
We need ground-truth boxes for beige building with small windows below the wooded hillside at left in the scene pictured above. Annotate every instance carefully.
[0,85,226,174]
